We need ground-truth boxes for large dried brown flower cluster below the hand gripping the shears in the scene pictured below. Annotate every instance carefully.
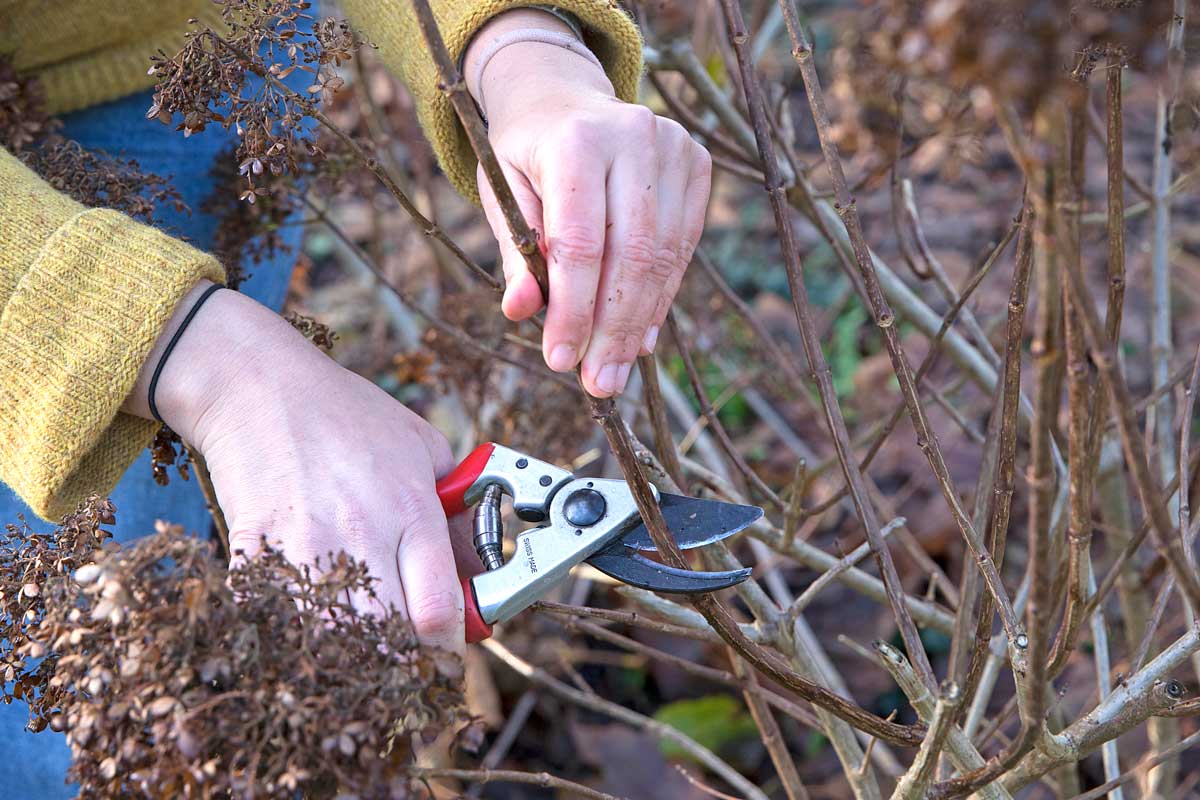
[0,498,466,798]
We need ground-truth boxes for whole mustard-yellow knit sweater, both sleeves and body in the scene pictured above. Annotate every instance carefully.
[0,0,641,522]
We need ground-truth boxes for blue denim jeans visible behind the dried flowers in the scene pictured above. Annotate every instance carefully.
[0,86,304,800]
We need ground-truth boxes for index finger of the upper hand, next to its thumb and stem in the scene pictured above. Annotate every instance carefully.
[539,137,607,372]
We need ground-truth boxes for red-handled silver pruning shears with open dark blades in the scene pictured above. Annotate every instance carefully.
[438,444,762,642]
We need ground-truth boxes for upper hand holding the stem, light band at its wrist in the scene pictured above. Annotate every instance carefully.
[467,10,712,397]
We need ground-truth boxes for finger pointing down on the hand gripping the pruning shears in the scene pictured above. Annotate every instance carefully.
[394,489,466,654]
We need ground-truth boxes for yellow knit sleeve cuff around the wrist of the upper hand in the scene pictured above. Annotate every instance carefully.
[341,0,642,203]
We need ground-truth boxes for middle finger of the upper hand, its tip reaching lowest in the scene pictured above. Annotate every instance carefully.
[582,107,674,397]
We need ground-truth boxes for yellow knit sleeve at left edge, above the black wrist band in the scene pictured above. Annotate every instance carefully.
[0,149,224,522]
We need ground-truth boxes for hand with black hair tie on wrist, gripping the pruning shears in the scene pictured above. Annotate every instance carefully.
[126,287,478,651]
